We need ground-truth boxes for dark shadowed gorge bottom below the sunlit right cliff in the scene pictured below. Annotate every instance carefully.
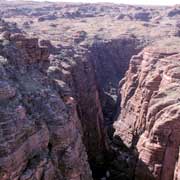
[91,131,155,180]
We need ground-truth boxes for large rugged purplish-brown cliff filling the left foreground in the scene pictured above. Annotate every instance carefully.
[0,24,92,180]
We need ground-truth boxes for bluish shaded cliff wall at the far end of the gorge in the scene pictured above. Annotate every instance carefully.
[90,35,142,126]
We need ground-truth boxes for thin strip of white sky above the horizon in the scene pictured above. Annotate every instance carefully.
[32,0,180,5]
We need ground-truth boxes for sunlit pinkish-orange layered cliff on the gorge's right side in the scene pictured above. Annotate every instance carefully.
[114,44,180,180]
